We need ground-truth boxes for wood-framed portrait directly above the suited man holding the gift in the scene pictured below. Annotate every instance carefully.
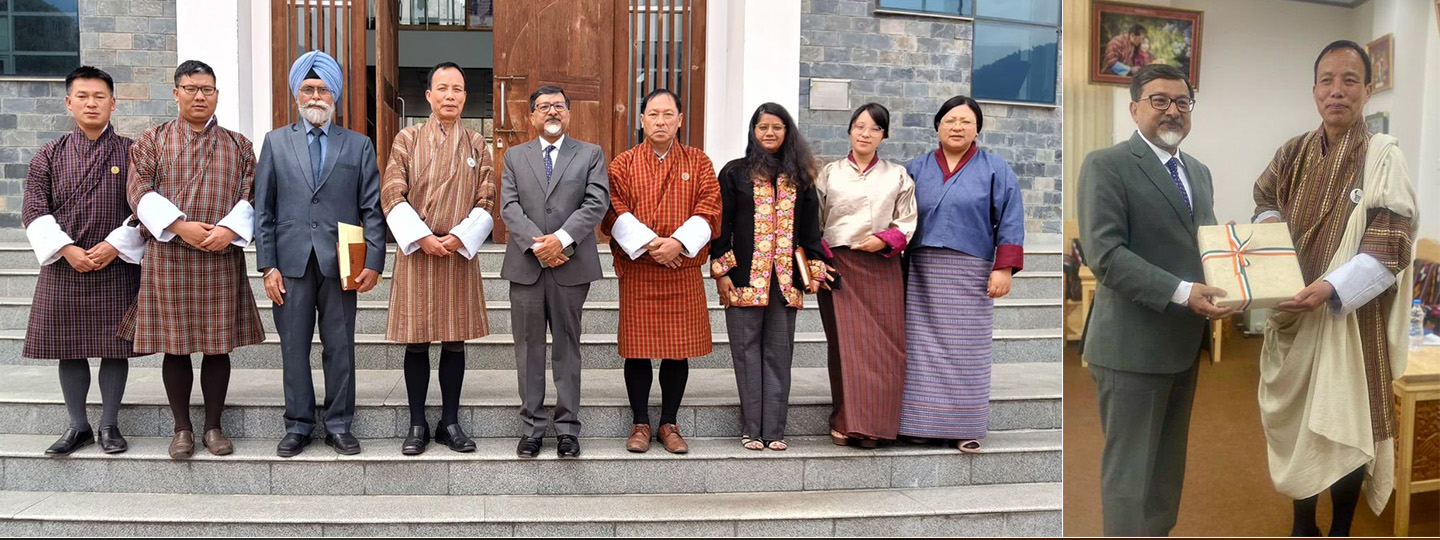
[1089,1,1205,88]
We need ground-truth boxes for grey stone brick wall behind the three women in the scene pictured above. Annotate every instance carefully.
[796,0,1061,243]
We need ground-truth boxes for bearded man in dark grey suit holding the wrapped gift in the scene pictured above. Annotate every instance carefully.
[1079,65,1233,536]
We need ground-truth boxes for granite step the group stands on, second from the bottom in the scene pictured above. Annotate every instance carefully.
[0,429,1061,495]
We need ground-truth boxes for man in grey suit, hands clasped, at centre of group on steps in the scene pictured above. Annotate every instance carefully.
[500,85,611,458]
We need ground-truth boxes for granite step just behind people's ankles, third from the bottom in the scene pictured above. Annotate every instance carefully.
[0,363,1061,439]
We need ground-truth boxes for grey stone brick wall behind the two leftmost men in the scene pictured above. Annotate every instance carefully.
[0,0,179,228]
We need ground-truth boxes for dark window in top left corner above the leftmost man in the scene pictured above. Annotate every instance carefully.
[0,0,81,76]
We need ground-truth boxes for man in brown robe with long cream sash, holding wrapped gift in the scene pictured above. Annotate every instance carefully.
[1254,40,1420,536]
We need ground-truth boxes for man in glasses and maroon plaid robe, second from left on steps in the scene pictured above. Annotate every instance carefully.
[120,60,265,459]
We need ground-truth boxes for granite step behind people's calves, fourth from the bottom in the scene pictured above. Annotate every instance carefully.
[0,328,1061,369]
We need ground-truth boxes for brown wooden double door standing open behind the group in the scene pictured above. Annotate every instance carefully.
[271,0,707,242]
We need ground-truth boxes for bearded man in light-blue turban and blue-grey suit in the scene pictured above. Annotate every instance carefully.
[255,50,386,458]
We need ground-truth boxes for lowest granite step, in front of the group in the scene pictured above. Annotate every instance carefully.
[0,482,1061,537]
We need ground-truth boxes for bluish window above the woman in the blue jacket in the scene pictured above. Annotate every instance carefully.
[877,0,1060,105]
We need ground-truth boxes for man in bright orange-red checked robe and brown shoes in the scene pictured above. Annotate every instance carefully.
[602,88,720,454]
